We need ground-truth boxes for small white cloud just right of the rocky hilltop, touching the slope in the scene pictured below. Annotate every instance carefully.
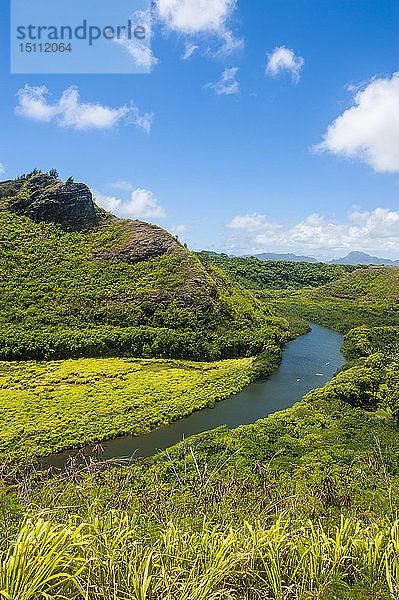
[93,188,166,219]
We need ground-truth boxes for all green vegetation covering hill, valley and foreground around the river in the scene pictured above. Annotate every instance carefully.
[5,173,399,600]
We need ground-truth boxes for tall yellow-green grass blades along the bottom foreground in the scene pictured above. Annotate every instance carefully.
[0,510,399,600]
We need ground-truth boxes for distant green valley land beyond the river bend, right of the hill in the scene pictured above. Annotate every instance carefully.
[198,252,399,333]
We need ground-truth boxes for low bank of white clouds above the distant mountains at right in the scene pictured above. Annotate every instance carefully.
[227,208,399,253]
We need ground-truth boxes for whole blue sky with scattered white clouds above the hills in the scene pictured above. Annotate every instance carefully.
[0,0,399,258]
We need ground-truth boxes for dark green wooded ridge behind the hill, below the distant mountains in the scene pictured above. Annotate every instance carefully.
[197,252,356,290]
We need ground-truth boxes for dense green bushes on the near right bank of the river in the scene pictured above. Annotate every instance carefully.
[145,353,399,482]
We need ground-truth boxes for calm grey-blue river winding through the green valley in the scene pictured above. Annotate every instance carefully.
[42,324,345,468]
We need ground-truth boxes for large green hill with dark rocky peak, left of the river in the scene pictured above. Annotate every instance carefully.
[0,173,287,359]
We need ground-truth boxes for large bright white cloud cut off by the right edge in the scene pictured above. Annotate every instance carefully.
[315,71,399,173]
